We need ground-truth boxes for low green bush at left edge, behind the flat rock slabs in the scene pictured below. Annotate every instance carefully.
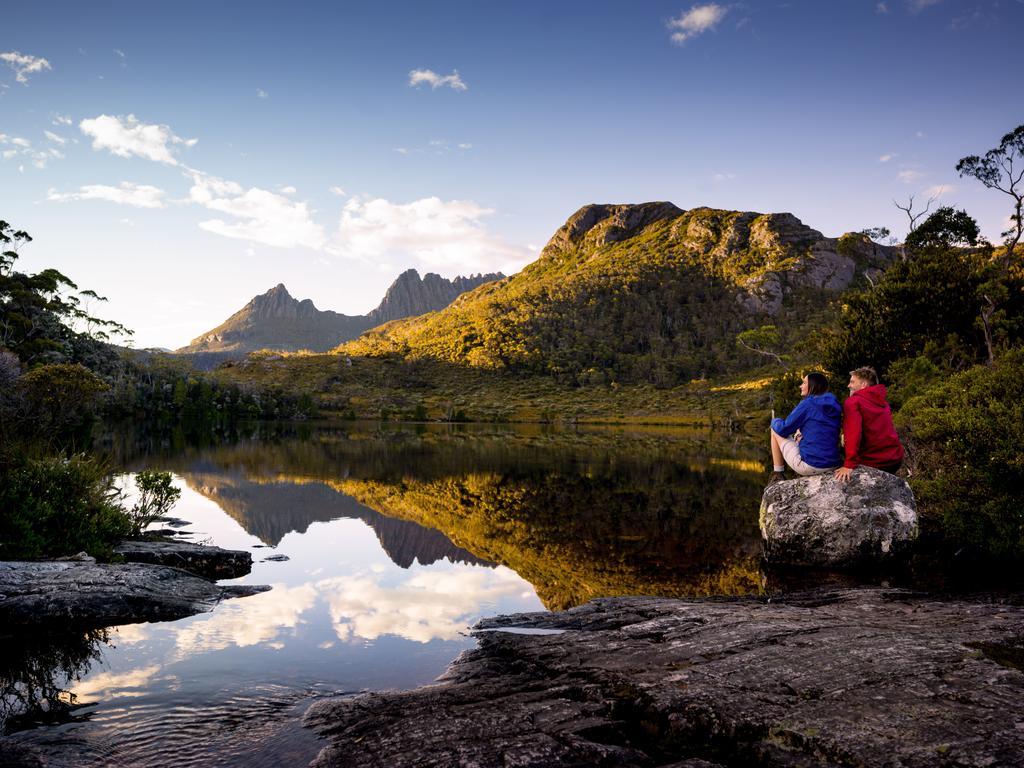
[0,456,131,560]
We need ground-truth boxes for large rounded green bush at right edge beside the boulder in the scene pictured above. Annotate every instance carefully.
[897,349,1024,557]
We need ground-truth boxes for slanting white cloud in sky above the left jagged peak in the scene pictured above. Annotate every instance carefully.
[188,170,326,249]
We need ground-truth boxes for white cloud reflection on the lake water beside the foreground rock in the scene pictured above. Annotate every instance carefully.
[316,567,522,643]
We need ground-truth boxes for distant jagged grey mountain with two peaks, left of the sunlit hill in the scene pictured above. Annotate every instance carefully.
[177,269,504,358]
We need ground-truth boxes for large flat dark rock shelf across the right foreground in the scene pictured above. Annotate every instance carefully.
[305,590,1024,768]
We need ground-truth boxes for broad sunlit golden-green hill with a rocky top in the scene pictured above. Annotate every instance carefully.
[339,203,898,384]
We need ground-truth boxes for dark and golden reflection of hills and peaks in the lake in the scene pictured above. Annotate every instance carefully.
[112,426,763,610]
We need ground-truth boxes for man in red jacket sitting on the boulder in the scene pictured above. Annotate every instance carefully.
[836,367,903,482]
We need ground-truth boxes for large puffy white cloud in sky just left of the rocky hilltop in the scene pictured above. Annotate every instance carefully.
[331,198,530,271]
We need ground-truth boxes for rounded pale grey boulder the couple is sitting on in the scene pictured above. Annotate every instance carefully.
[761,467,918,567]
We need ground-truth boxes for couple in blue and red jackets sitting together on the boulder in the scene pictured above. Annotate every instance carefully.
[771,368,903,482]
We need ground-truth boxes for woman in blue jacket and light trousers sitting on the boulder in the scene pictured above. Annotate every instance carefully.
[771,372,843,481]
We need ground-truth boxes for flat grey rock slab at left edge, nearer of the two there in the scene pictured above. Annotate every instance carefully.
[0,561,270,627]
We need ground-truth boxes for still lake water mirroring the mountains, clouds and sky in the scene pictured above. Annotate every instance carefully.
[0,425,764,768]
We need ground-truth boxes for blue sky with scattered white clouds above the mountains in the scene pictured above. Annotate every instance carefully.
[0,0,1024,348]
